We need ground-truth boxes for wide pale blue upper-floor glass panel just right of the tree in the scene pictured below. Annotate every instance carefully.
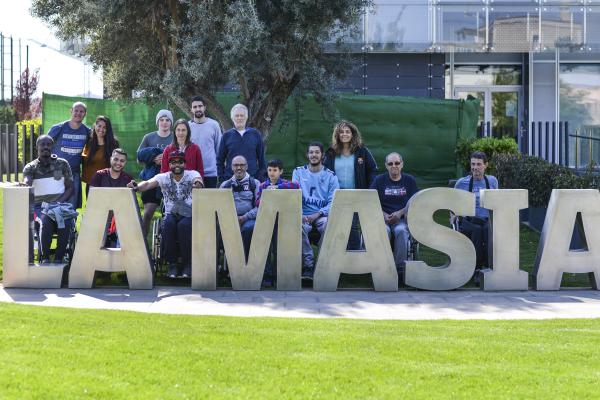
[367,4,432,50]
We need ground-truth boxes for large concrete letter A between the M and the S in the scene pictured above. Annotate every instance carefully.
[313,190,398,291]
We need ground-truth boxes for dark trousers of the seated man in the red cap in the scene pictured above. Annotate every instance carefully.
[162,214,192,266]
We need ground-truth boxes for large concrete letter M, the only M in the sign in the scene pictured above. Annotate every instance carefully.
[192,189,302,290]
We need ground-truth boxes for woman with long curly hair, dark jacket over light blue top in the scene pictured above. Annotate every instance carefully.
[323,121,377,250]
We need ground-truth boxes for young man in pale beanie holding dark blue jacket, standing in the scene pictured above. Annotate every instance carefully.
[137,110,173,237]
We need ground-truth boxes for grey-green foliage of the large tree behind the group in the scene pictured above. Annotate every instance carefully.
[32,0,370,136]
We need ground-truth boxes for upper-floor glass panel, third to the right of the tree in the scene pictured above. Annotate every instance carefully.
[489,5,539,51]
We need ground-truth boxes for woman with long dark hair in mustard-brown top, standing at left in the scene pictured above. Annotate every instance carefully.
[81,115,119,198]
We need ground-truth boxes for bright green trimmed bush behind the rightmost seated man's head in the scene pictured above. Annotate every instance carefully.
[455,136,519,175]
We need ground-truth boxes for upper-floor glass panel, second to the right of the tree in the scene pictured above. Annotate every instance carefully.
[436,5,486,50]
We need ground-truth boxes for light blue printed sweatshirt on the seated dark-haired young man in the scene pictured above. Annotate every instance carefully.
[292,165,340,216]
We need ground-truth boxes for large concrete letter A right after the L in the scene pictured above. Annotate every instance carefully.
[69,187,152,289]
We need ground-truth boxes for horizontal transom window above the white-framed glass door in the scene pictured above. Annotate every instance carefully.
[454,65,521,86]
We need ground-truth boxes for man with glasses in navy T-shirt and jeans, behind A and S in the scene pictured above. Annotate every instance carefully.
[371,152,419,273]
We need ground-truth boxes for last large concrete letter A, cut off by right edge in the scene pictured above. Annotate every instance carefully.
[533,189,600,290]
